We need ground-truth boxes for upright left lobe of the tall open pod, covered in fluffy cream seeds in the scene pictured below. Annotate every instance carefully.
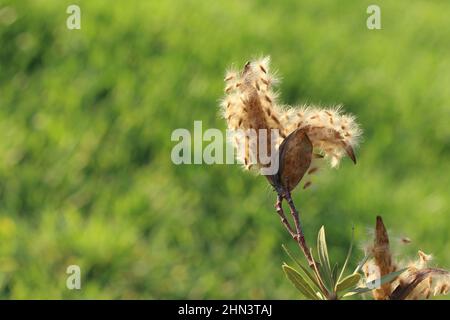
[221,57,286,169]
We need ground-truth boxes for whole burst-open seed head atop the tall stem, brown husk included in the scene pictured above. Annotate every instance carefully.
[220,57,362,191]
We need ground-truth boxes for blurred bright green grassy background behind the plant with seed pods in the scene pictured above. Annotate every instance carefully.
[0,0,450,299]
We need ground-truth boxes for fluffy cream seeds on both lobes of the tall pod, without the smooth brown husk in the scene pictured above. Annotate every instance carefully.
[221,57,361,178]
